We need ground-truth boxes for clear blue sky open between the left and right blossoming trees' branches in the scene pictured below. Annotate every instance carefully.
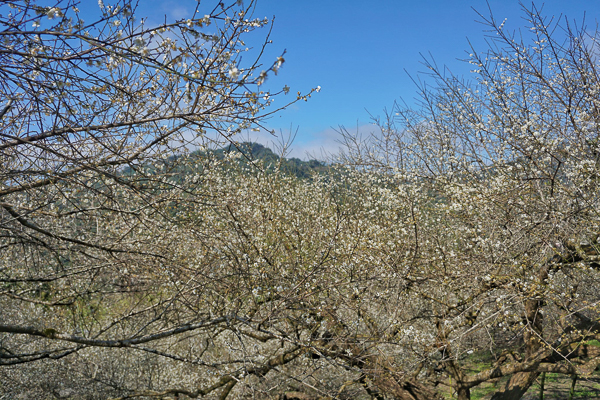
[130,0,600,158]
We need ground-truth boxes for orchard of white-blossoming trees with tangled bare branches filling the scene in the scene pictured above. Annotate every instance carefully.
[0,0,600,400]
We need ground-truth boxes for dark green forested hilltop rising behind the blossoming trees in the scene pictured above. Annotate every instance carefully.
[192,142,327,178]
